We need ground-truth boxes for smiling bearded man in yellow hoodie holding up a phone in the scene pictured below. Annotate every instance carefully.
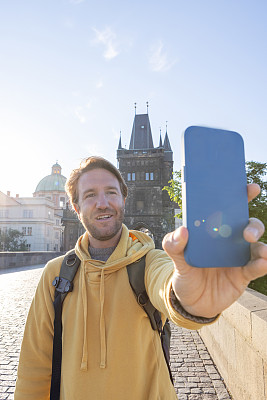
[15,157,267,400]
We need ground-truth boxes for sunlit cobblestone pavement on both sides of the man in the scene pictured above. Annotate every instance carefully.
[0,265,231,400]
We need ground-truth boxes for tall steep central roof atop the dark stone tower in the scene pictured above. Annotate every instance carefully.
[129,114,154,150]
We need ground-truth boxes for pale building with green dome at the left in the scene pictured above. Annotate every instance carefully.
[0,163,67,251]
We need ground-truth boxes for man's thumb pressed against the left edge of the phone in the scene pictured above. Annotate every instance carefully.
[162,226,188,261]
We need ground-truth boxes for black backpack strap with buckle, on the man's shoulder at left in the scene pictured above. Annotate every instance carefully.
[50,250,81,400]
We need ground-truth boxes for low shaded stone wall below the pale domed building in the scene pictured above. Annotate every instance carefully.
[0,251,63,269]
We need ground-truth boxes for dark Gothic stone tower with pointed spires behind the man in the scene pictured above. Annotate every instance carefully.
[117,109,174,248]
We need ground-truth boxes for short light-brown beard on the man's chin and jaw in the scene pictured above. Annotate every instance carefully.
[80,206,124,241]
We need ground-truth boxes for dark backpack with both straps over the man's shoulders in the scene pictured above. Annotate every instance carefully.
[50,250,173,400]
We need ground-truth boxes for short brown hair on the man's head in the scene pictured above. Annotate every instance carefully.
[65,156,128,206]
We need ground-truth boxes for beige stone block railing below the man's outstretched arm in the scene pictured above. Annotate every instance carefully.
[200,289,267,400]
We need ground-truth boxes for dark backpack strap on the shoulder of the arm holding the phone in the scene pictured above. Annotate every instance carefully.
[127,256,173,383]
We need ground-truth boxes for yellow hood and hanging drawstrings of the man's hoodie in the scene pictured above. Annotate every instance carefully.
[75,225,155,371]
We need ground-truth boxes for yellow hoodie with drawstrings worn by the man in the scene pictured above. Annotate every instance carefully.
[14,225,214,400]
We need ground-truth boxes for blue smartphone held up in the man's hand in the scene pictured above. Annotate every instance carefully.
[182,126,250,268]
